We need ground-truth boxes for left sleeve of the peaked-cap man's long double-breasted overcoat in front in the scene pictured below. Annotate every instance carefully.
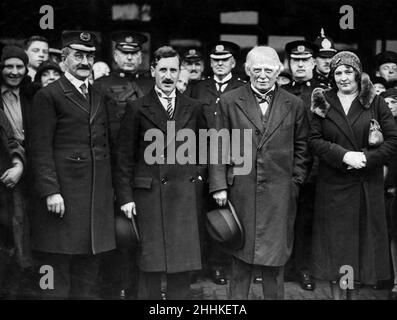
[30,90,61,197]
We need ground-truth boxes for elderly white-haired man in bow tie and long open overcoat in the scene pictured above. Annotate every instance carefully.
[210,46,309,299]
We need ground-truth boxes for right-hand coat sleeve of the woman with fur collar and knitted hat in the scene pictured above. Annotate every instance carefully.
[364,99,397,169]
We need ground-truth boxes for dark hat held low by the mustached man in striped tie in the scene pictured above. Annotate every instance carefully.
[115,214,140,249]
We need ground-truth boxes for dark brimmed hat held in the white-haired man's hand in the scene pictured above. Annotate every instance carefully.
[206,201,244,249]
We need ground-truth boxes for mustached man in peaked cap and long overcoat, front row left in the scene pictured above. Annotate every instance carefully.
[30,31,115,299]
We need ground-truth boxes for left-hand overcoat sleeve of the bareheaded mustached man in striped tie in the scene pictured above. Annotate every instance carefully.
[114,101,139,206]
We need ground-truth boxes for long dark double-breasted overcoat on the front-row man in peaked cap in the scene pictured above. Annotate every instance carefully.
[31,76,115,254]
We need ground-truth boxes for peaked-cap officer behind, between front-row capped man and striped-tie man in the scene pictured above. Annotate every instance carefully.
[94,31,148,299]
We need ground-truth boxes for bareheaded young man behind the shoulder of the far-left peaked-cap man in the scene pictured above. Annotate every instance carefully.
[24,35,49,81]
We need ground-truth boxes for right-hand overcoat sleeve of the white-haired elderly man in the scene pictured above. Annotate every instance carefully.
[293,100,310,185]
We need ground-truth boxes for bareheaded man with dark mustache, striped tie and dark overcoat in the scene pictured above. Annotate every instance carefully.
[115,47,206,299]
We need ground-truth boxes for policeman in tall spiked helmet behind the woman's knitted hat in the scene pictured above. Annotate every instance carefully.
[313,28,337,88]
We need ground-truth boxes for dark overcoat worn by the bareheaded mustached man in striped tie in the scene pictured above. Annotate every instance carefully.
[115,89,206,273]
